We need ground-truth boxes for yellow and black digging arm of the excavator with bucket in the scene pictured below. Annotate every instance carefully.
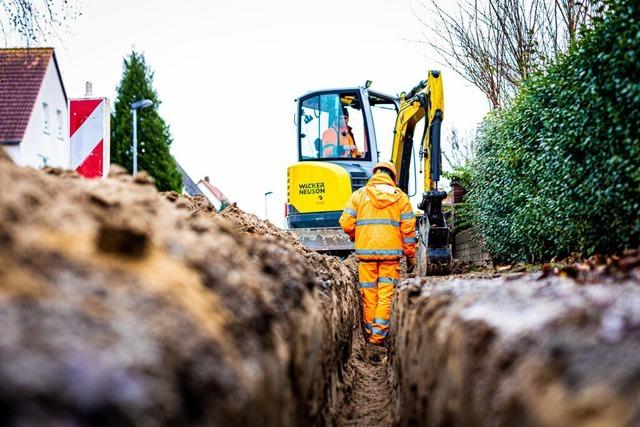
[391,71,451,276]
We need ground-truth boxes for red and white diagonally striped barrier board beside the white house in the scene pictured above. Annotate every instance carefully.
[69,98,110,178]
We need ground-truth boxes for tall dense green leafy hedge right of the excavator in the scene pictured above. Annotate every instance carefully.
[467,0,640,261]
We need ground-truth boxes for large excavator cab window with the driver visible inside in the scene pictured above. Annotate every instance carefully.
[299,92,371,161]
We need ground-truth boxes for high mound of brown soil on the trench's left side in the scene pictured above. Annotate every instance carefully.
[0,150,358,426]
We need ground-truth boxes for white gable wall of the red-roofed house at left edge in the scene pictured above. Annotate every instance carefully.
[16,58,70,169]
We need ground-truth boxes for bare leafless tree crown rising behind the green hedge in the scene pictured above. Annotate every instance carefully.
[414,0,603,108]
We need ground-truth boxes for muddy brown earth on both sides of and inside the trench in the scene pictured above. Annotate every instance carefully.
[0,150,640,426]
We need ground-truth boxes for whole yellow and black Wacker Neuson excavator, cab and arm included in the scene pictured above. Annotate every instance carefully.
[286,70,451,276]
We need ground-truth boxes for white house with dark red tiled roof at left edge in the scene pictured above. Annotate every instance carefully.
[0,48,70,168]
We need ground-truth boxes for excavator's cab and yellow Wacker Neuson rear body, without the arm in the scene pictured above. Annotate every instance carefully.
[286,82,400,253]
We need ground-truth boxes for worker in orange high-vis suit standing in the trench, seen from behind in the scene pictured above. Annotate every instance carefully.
[340,162,416,345]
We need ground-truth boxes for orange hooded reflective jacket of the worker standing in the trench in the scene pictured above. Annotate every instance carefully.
[340,172,416,261]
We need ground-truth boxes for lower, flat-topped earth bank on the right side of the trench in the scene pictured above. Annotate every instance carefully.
[390,272,640,426]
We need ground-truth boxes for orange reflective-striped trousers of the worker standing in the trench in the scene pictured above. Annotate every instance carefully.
[358,260,400,344]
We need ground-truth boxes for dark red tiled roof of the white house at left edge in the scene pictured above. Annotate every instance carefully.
[0,47,67,145]
